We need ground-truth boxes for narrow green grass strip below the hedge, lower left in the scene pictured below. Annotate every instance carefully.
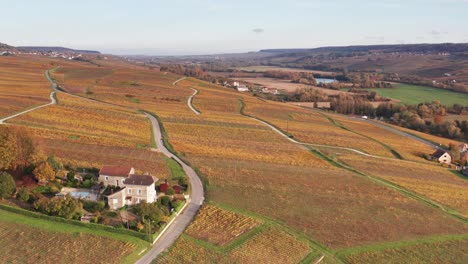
[0,209,150,263]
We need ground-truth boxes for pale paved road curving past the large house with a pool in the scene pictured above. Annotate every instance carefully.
[136,113,205,264]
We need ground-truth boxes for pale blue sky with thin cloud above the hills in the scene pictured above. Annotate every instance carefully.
[0,0,468,55]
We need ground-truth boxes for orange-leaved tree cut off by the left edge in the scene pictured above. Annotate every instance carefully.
[0,126,17,170]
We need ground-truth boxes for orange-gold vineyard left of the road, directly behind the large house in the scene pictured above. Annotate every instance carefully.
[8,70,169,176]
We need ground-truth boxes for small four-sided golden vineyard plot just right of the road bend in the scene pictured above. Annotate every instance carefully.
[186,205,260,246]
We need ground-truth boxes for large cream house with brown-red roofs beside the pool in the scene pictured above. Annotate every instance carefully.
[99,166,158,210]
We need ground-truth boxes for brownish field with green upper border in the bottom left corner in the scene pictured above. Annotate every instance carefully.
[0,210,149,263]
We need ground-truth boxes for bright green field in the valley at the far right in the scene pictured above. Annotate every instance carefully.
[366,83,468,106]
